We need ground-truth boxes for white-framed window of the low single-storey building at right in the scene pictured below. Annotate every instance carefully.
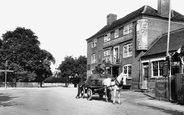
[152,60,164,77]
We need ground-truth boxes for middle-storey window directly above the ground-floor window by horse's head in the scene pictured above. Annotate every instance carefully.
[123,44,132,58]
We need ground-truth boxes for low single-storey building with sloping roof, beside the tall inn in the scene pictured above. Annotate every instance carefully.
[140,28,184,91]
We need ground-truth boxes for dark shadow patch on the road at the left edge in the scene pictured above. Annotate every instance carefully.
[0,93,17,107]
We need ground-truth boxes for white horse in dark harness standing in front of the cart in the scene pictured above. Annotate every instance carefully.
[102,72,126,104]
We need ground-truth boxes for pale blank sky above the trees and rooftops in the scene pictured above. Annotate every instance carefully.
[0,0,184,70]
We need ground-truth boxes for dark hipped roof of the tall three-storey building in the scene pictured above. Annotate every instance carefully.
[86,5,184,40]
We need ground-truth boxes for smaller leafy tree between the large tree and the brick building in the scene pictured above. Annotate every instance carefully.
[59,56,87,77]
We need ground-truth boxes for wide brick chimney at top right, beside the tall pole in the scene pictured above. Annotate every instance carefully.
[158,0,170,18]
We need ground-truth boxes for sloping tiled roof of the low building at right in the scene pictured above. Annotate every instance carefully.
[142,28,184,57]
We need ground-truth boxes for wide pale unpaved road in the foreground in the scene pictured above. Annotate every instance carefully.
[0,86,182,115]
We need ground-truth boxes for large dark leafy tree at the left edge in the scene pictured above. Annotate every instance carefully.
[0,27,55,85]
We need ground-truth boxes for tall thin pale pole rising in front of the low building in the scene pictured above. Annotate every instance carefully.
[166,0,171,100]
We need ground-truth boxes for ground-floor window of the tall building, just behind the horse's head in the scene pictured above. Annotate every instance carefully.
[123,64,132,78]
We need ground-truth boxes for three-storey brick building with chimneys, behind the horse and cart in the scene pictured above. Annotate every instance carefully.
[86,0,184,89]
